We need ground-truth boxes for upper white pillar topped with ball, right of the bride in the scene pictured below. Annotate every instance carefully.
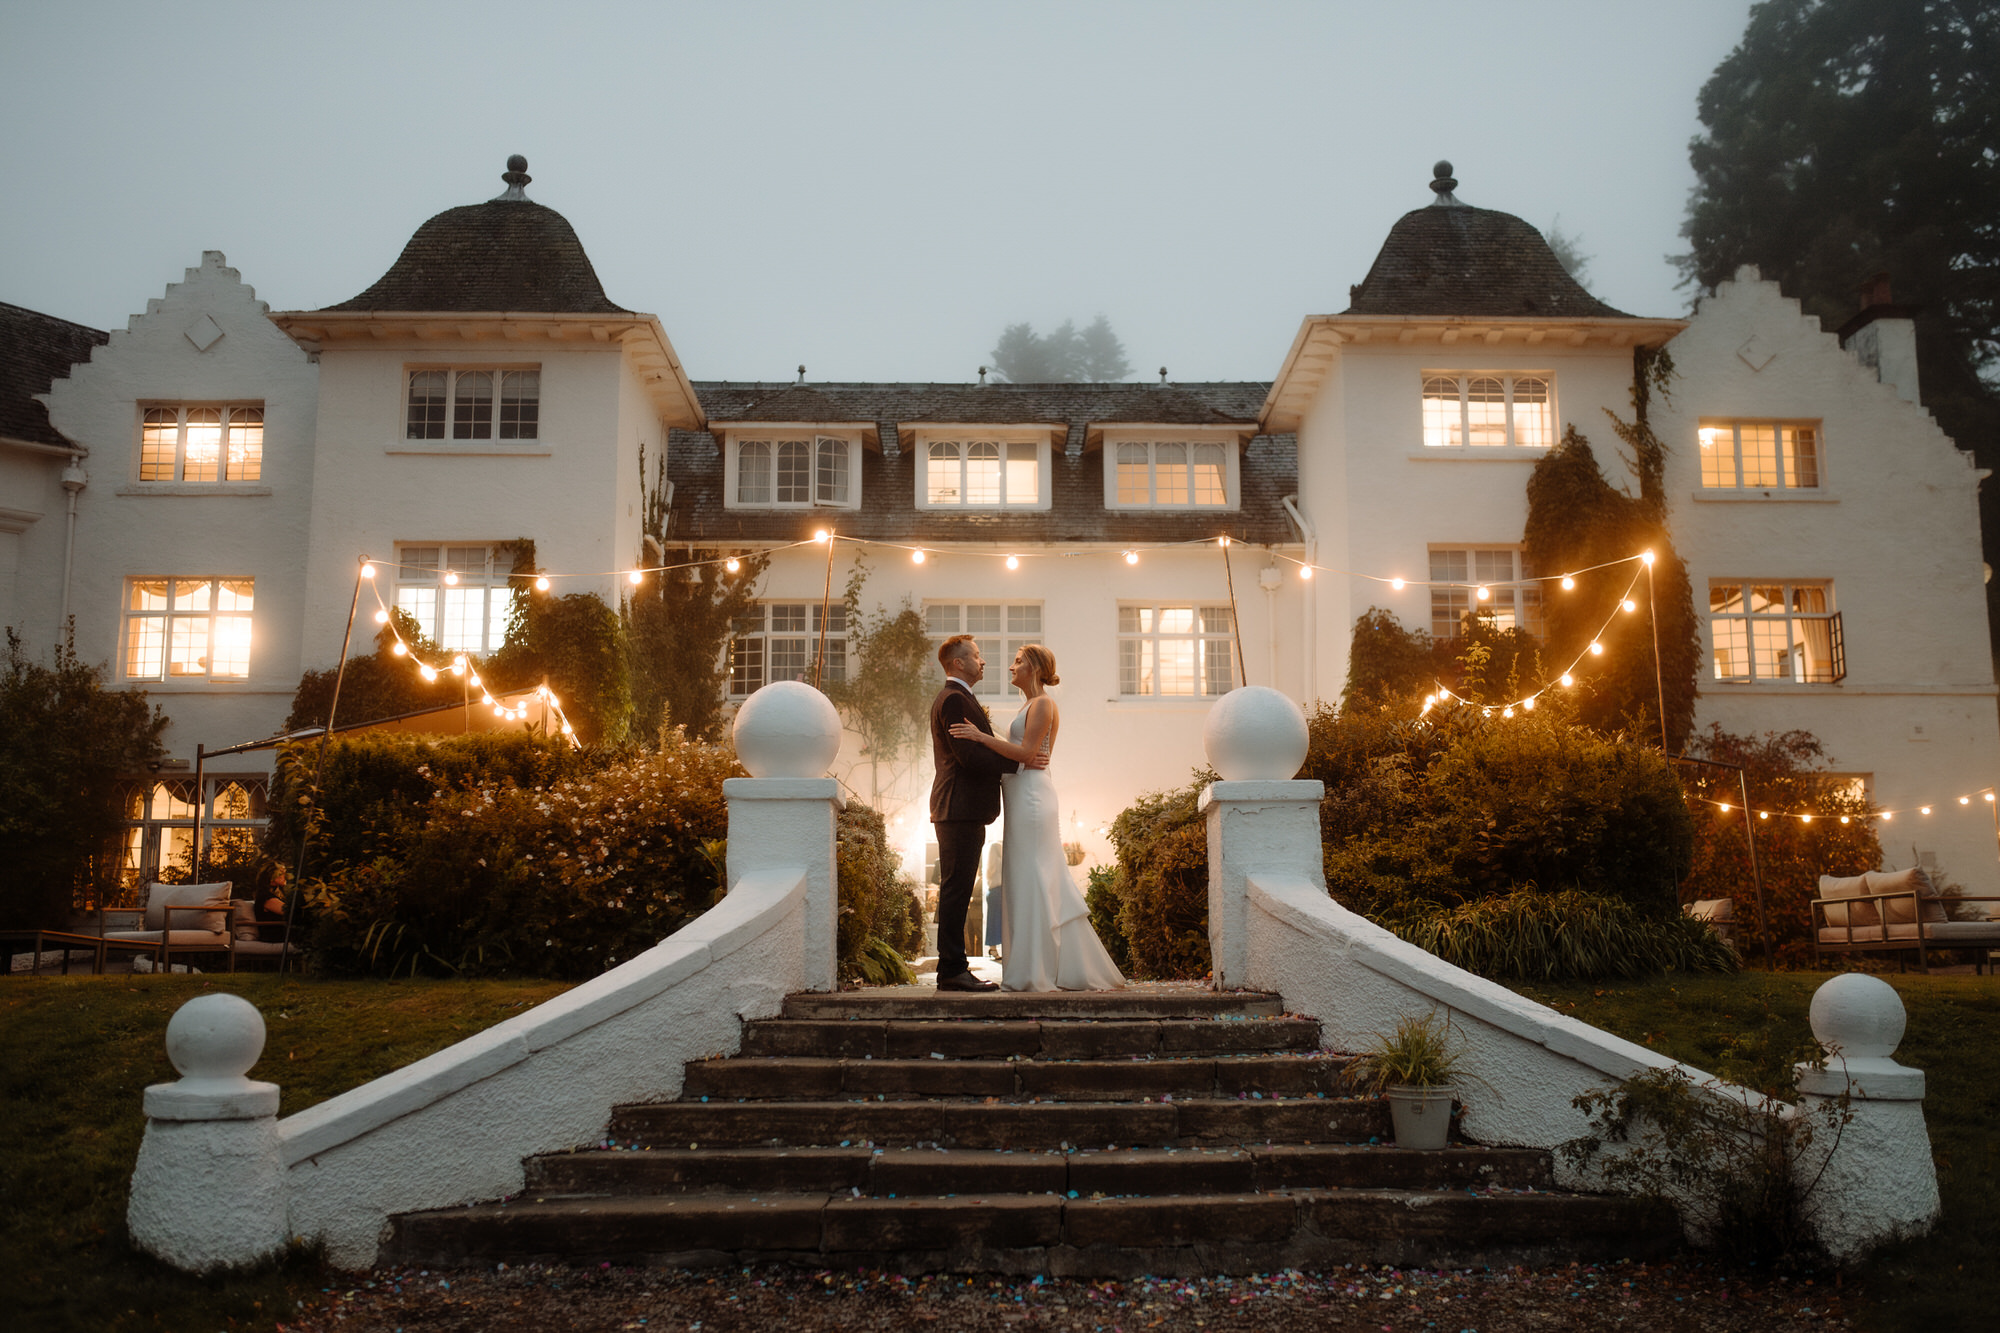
[1200,685,1326,991]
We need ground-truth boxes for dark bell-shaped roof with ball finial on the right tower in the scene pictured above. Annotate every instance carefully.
[1342,162,1634,320]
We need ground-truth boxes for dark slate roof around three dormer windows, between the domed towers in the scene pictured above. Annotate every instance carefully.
[666,382,1298,546]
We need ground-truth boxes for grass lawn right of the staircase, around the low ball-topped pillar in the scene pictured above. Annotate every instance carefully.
[1516,971,2000,1333]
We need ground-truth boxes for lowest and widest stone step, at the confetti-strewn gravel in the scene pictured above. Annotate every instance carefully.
[384,1189,1680,1277]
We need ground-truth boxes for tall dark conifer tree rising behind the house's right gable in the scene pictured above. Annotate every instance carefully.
[1676,0,2000,648]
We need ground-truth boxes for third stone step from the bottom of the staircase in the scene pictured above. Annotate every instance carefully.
[610,1097,1388,1149]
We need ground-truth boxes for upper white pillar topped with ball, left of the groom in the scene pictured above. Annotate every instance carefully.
[722,681,842,991]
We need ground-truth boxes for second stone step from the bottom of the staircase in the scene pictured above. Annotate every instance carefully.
[524,1143,1552,1199]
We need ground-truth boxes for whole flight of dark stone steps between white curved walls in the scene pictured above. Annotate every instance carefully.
[384,985,1680,1277]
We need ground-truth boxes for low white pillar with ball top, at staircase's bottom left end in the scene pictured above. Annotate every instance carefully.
[126,995,286,1273]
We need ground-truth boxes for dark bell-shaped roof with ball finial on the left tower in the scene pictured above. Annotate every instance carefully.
[326,154,630,314]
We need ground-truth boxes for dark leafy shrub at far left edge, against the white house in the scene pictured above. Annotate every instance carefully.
[0,628,166,929]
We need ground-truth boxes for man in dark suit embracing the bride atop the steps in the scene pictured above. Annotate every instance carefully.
[930,634,1048,991]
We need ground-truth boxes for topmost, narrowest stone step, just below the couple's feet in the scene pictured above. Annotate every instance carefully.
[782,985,1284,1023]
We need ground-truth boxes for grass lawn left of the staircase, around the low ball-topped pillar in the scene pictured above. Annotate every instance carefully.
[0,973,568,1333]
